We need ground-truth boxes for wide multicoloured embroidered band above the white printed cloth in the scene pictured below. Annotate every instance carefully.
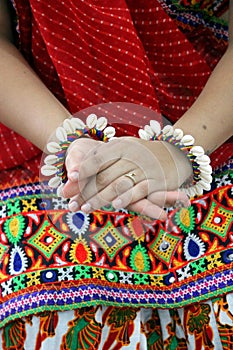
[0,163,233,325]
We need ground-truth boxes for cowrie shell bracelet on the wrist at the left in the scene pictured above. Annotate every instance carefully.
[41,114,115,196]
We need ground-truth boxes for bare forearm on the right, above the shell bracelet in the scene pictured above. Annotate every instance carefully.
[175,3,233,153]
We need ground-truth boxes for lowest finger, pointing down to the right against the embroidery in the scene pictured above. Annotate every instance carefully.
[128,199,167,221]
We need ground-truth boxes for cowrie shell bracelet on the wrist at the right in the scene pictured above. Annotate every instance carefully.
[139,120,212,197]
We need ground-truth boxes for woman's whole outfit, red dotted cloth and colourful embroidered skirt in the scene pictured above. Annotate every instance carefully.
[0,0,233,350]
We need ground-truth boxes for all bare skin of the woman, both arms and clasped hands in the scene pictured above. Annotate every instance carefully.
[0,1,233,219]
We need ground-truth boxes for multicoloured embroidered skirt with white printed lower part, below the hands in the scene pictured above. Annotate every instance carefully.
[0,161,233,350]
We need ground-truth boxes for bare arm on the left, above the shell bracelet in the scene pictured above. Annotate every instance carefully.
[0,0,69,149]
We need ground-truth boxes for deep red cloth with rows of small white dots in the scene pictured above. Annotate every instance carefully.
[0,0,232,178]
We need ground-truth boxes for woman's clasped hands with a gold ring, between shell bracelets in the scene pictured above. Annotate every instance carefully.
[62,137,192,220]
